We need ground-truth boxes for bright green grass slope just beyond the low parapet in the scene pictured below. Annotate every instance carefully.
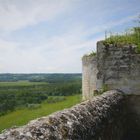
[0,95,81,132]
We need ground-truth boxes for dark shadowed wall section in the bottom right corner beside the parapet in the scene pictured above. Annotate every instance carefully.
[124,95,140,140]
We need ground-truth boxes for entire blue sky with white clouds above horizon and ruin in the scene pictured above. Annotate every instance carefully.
[0,0,140,73]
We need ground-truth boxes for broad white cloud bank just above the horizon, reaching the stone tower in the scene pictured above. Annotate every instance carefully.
[0,30,104,73]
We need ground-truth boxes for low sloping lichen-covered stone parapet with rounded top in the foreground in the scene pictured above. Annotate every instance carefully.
[0,90,127,140]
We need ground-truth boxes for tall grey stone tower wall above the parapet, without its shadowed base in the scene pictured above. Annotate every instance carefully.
[83,41,140,99]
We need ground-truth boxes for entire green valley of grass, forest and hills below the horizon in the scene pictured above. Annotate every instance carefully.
[0,74,81,132]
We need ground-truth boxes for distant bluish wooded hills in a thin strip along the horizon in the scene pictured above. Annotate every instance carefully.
[0,73,81,85]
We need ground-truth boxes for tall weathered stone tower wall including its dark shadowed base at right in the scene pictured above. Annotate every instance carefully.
[83,41,140,140]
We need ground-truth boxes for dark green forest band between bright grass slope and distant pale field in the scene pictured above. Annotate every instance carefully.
[0,79,81,115]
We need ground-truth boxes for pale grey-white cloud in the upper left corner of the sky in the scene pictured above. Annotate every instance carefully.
[0,0,70,31]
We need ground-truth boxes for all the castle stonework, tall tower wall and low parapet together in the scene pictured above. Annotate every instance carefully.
[0,42,140,140]
